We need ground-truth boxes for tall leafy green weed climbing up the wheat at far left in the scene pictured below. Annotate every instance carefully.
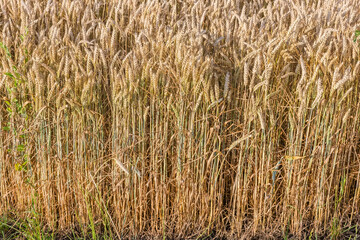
[0,32,48,240]
